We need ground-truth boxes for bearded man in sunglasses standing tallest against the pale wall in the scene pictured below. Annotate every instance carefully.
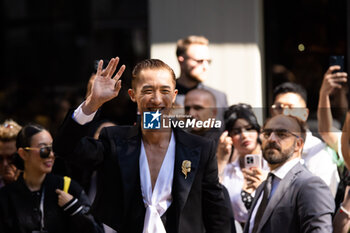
[175,36,227,122]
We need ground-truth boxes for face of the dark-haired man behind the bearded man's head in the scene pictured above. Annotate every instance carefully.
[271,92,309,122]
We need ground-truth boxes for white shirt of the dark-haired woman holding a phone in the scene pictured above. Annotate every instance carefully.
[222,154,269,222]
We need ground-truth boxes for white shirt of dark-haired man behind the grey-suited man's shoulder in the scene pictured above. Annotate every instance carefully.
[301,131,341,197]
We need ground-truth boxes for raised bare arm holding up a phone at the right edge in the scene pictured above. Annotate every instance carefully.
[317,66,347,152]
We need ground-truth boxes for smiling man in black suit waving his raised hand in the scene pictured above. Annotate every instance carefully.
[54,58,230,233]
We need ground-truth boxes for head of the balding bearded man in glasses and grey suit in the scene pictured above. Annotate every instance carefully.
[261,115,303,167]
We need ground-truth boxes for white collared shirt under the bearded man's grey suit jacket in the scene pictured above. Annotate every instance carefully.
[248,158,300,233]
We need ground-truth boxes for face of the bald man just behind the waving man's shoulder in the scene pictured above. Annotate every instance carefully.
[185,91,216,131]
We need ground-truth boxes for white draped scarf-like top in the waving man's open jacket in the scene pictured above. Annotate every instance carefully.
[140,132,175,233]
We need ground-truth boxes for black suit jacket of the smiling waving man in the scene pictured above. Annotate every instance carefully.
[53,114,230,233]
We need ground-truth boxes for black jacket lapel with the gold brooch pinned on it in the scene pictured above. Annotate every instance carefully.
[172,130,201,214]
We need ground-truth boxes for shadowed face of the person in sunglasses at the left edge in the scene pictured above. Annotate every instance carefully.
[0,141,17,183]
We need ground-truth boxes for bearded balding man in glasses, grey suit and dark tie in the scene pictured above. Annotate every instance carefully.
[244,115,334,233]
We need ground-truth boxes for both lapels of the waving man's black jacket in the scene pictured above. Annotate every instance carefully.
[116,127,201,228]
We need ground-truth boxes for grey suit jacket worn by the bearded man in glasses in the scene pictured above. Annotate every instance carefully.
[244,163,335,233]
